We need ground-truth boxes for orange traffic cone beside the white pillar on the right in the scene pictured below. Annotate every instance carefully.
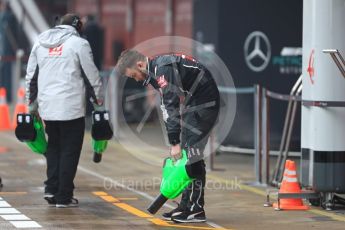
[273,160,308,210]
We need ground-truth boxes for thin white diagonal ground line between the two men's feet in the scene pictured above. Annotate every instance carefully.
[78,166,224,228]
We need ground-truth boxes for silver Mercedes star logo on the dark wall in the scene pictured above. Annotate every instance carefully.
[244,31,271,72]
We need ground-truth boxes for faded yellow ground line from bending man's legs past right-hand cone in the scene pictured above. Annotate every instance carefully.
[207,175,345,222]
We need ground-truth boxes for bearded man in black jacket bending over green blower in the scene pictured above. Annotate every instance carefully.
[116,50,219,222]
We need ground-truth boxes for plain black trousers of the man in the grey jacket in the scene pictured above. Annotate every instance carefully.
[44,117,85,204]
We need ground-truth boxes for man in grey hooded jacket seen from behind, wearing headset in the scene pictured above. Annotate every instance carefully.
[26,14,103,208]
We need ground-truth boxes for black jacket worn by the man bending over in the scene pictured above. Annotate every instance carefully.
[146,55,219,145]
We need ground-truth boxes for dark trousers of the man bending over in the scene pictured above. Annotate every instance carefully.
[180,103,219,211]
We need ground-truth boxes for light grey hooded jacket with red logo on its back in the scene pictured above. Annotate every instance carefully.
[25,25,102,120]
